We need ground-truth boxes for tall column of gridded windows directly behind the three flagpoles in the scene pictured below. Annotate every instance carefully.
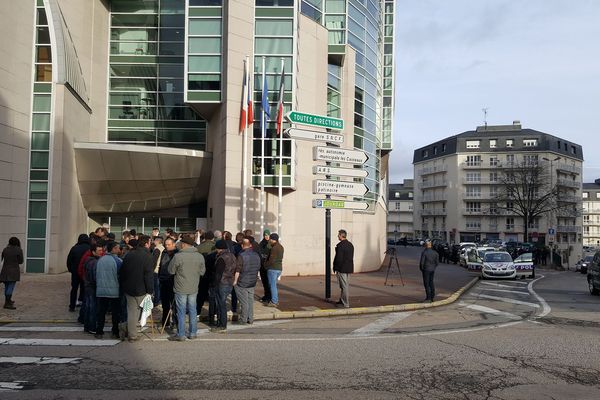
[252,0,296,187]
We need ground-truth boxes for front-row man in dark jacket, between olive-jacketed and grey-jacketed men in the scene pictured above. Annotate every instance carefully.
[211,240,237,333]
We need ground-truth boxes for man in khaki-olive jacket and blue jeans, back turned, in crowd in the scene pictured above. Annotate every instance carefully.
[169,235,206,341]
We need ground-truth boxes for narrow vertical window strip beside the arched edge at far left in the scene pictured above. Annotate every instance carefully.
[25,1,52,273]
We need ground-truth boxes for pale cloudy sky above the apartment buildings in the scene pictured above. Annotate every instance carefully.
[390,0,600,183]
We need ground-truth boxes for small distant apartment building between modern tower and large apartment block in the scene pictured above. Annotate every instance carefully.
[387,179,414,240]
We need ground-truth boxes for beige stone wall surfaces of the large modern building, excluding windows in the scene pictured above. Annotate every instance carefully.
[0,0,390,275]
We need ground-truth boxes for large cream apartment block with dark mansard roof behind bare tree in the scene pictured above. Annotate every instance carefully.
[413,121,583,266]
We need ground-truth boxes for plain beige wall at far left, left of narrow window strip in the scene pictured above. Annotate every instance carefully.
[0,0,34,253]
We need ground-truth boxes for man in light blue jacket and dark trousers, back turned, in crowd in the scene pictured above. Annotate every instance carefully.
[95,242,123,339]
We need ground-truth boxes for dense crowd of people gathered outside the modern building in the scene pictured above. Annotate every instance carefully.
[68,227,284,341]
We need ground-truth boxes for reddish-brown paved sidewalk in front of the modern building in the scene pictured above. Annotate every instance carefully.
[0,252,476,323]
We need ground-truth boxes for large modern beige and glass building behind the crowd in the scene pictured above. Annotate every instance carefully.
[0,0,395,275]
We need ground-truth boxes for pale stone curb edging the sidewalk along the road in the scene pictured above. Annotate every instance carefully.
[0,278,479,325]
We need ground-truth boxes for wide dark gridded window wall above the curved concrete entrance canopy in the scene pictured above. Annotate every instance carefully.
[108,0,207,150]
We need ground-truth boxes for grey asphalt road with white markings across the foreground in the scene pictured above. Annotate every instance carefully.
[0,264,600,400]
